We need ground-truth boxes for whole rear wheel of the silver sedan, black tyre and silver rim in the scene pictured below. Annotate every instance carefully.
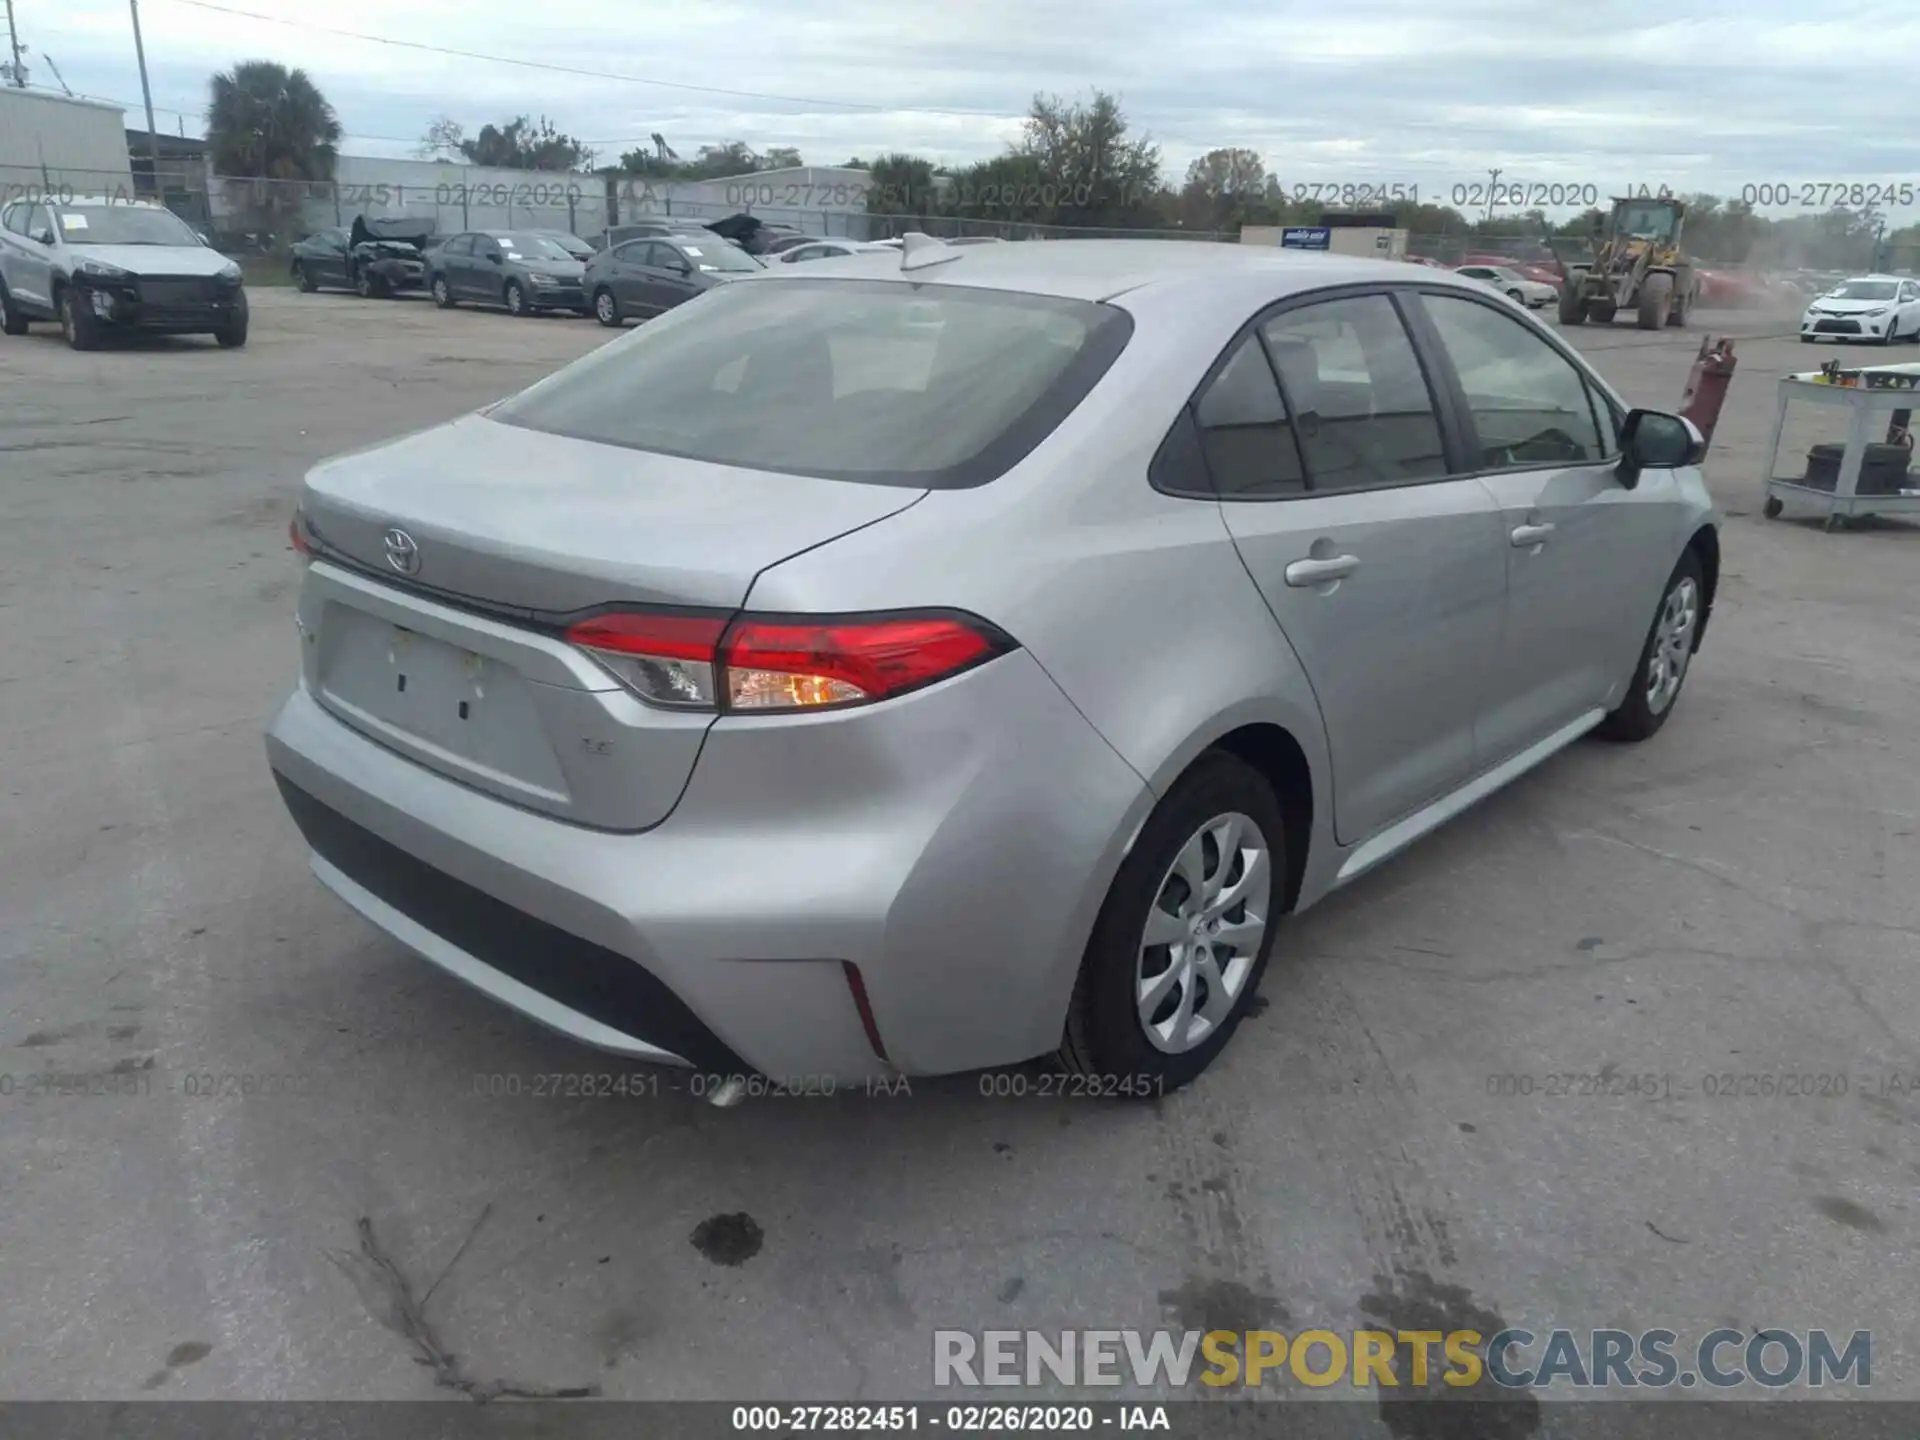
[1058,753,1288,1098]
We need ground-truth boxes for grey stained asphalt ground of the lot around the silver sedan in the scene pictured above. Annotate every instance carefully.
[0,292,1920,1432]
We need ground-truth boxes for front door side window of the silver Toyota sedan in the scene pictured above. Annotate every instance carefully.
[1421,294,1613,470]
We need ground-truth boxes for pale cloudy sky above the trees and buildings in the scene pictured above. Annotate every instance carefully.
[13,0,1920,213]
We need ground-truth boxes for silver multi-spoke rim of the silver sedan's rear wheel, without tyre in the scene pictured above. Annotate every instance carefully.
[1135,812,1273,1054]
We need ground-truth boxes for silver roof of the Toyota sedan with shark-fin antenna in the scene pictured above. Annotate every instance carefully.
[741,240,1505,301]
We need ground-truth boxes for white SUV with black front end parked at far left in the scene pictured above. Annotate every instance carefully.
[0,196,248,349]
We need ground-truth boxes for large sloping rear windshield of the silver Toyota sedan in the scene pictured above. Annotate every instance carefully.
[490,278,1133,490]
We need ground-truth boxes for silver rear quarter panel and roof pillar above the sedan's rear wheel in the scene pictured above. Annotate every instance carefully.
[747,278,1332,925]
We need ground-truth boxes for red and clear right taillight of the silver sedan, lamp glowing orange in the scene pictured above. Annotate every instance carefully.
[566,611,1012,712]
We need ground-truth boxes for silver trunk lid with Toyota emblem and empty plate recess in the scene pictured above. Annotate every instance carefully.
[300,415,925,831]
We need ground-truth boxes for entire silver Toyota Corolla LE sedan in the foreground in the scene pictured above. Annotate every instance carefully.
[267,236,1720,1094]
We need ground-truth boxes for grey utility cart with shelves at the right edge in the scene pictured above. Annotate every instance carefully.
[1764,361,1920,530]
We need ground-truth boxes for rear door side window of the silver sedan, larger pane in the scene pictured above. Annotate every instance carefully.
[1260,296,1448,492]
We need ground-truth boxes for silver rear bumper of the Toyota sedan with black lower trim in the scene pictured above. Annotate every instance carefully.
[267,651,1150,1085]
